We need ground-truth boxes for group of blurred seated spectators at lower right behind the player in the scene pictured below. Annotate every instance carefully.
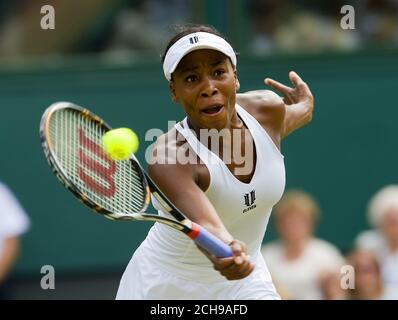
[262,185,398,300]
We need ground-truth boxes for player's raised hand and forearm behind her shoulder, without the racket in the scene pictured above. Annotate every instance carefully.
[264,71,314,139]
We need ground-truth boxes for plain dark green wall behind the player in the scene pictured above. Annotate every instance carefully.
[0,51,398,275]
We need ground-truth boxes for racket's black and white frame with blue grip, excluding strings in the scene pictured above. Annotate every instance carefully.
[40,102,232,257]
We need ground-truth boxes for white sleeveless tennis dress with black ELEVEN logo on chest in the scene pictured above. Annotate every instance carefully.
[116,105,285,300]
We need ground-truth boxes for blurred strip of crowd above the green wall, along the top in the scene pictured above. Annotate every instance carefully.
[0,0,398,61]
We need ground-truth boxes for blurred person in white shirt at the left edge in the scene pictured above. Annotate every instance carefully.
[0,183,29,300]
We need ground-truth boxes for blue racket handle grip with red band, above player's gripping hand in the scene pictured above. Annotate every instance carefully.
[188,223,232,258]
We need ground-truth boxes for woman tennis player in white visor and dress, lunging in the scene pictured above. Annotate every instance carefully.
[116,26,313,300]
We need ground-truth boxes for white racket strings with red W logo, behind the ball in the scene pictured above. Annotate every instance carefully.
[49,109,146,214]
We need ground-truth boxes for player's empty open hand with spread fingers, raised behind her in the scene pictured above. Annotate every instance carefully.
[264,71,314,107]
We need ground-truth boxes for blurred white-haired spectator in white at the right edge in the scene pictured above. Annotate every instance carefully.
[355,185,398,293]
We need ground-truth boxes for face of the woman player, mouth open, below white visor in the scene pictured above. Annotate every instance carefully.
[170,49,239,129]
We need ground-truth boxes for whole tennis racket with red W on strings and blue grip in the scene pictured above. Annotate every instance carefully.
[40,102,232,257]
